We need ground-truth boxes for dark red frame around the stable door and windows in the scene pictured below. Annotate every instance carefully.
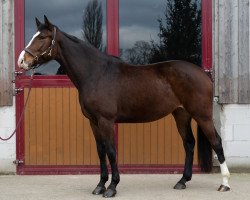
[14,0,212,174]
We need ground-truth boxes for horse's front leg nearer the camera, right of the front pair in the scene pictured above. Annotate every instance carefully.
[98,118,120,197]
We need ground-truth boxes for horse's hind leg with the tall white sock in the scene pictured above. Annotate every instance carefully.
[197,119,230,192]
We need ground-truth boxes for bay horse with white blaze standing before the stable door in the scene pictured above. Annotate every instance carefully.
[18,16,230,197]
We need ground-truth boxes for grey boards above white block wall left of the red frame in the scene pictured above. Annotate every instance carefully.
[0,0,16,173]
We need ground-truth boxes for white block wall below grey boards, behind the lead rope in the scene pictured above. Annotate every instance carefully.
[0,102,16,173]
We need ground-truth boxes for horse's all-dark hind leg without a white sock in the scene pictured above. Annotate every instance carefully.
[172,108,195,189]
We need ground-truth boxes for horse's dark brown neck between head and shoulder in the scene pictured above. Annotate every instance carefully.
[57,32,102,88]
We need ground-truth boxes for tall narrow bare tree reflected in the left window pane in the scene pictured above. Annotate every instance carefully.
[82,0,103,49]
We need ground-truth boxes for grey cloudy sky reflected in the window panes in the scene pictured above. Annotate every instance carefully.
[25,0,166,48]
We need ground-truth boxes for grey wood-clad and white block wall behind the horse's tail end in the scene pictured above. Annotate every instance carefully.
[213,0,250,168]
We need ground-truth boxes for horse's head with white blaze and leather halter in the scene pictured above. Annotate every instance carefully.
[18,16,57,70]
